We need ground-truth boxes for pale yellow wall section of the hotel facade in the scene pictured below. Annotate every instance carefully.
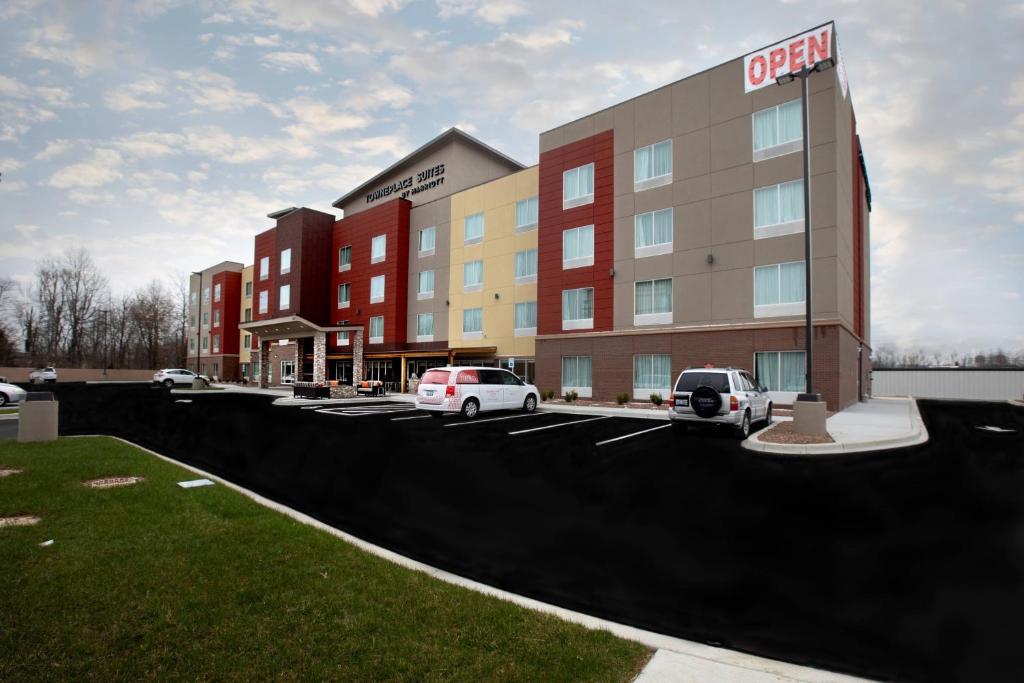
[447,166,538,358]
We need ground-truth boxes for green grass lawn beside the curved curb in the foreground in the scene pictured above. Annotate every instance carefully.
[0,438,650,681]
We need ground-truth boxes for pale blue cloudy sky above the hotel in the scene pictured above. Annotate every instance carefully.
[0,0,1024,349]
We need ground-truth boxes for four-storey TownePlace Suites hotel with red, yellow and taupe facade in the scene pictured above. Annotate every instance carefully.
[188,25,870,410]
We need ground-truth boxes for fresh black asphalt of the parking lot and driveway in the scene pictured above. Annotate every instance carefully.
[32,385,1024,681]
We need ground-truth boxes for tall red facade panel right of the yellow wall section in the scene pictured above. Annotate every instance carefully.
[537,130,614,335]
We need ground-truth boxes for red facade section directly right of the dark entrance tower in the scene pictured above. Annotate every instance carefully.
[328,194,412,353]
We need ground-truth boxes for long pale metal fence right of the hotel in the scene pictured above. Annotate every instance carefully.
[871,368,1024,400]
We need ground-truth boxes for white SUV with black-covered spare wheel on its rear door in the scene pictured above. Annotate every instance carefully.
[669,367,772,438]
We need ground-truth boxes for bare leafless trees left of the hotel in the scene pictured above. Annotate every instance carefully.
[0,248,188,369]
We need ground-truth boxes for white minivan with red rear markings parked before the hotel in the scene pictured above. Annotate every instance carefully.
[416,367,541,418]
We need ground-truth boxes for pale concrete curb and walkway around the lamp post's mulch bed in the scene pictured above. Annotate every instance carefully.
[743,398,928,455]
